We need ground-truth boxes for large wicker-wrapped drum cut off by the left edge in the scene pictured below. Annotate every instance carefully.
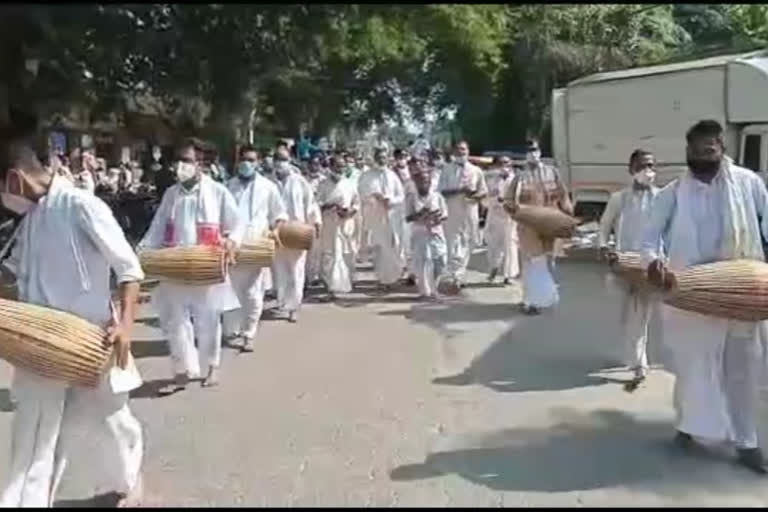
[0,299,111,387]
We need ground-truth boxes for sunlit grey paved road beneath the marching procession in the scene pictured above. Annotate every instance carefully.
[0,255,768,506]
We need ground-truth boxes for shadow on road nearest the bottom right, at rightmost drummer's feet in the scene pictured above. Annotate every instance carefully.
[390,410,759,495]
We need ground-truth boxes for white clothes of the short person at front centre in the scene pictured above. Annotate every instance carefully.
[405,191,448,297]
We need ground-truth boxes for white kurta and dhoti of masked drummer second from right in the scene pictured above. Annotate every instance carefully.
[599,186,661,374]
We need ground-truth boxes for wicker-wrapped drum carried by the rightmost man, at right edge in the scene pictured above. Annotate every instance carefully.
[664,260,768,322]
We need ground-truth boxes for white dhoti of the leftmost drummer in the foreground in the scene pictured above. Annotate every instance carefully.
[0,368,144,507]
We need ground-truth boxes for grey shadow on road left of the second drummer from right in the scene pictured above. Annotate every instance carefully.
[379,262,656,392]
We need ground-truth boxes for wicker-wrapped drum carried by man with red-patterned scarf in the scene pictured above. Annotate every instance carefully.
[139,245,227,285]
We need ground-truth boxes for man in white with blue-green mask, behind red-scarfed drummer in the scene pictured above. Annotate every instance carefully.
[224,146,288,352]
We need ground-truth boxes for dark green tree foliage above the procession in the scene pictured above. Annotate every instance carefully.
[0,4,768,149]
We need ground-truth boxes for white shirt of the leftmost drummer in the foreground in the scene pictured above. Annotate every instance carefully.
[6,176,144,326]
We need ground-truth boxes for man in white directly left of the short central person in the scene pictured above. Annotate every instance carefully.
[358,149,405,291]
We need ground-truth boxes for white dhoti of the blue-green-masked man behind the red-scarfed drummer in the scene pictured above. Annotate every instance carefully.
[224,266,269,340]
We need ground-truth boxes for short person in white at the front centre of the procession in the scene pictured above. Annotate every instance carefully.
[405,157,448,300]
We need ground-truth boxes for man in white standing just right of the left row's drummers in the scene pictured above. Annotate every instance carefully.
[317,156,360,300]
